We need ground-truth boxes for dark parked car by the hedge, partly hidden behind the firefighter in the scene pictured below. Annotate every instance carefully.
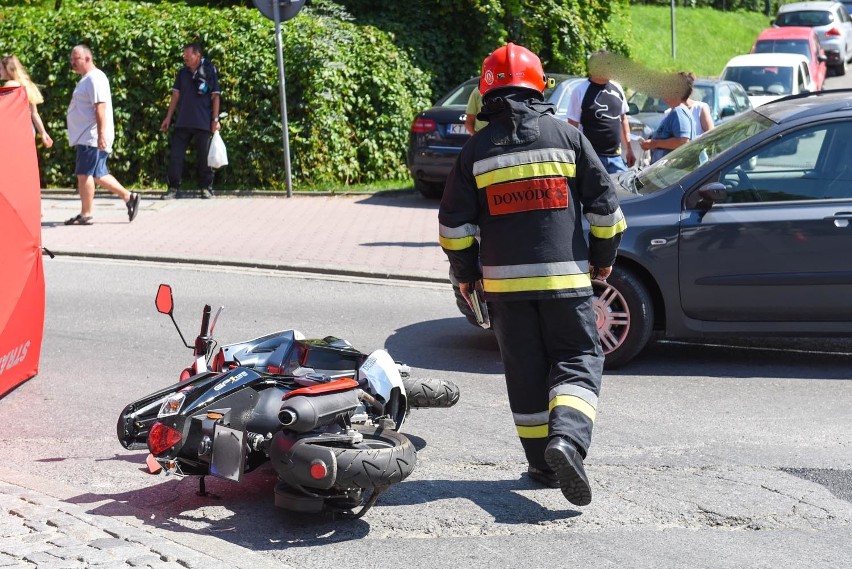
[407,74,584,198]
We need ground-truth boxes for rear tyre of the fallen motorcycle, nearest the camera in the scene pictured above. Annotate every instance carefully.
[331,425,417,489]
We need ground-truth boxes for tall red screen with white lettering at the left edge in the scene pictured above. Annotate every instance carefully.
[0,87,44,397]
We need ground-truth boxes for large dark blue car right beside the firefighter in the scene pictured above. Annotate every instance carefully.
[456,89,852,368]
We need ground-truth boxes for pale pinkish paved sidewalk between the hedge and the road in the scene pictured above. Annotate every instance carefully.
[42,191,449,282]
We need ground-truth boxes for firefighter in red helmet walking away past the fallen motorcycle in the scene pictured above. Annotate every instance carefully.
[438,43,627,506]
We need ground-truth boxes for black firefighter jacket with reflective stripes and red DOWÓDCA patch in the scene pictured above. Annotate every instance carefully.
[438,89,627,301]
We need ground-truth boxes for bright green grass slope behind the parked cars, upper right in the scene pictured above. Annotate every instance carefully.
[611,4,770,77]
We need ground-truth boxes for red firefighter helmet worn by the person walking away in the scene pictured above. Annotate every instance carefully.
[479,43,547,96]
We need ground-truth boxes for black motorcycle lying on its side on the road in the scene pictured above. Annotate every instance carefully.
[116,285,459,517]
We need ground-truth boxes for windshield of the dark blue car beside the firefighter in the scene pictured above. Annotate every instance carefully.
[618,111,775,195]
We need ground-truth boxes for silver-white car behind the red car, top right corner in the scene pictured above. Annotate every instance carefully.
[771,2,852,75]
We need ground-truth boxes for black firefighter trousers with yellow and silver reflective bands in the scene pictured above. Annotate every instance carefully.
[488,297,604,470]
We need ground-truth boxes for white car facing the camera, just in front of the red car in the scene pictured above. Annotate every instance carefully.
[721,53,817,107]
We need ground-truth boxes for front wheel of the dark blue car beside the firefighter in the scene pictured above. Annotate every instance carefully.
[592,267,654,369]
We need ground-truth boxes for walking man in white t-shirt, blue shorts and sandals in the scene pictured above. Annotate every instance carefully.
[65,45,139,225]
